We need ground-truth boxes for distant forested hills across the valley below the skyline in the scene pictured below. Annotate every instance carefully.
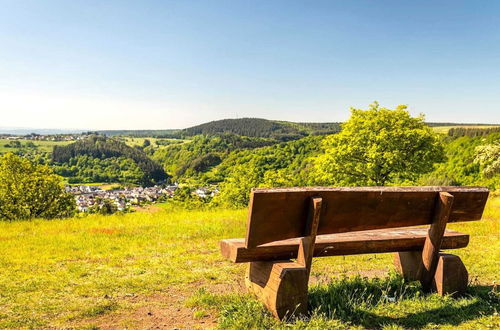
[0,118,500,191]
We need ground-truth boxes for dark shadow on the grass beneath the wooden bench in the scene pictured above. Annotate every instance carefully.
[309,276,500,329]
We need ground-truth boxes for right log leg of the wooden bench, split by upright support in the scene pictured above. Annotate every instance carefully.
[394,251,469,296]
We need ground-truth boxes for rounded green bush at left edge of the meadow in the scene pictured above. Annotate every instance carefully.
[0,153,75,221]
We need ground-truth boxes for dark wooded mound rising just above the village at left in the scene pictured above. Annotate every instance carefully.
[52,135,167,186]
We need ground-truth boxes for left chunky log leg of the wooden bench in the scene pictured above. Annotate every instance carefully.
[245,261,309,320]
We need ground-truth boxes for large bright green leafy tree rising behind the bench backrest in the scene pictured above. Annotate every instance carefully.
[315,103,444,186]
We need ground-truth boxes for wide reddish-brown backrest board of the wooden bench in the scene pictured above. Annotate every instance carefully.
[246,187,489,248]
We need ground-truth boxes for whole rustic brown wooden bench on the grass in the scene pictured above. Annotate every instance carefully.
[221,187,488,319]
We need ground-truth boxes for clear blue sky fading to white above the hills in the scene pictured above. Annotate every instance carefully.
[0,0,500,129]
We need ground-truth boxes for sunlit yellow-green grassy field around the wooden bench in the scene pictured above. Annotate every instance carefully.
[0,196,500,329]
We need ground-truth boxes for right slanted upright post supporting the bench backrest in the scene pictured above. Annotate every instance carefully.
[418,192,454,291]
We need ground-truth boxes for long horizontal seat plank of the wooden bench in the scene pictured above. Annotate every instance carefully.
[220,228,469,263]
